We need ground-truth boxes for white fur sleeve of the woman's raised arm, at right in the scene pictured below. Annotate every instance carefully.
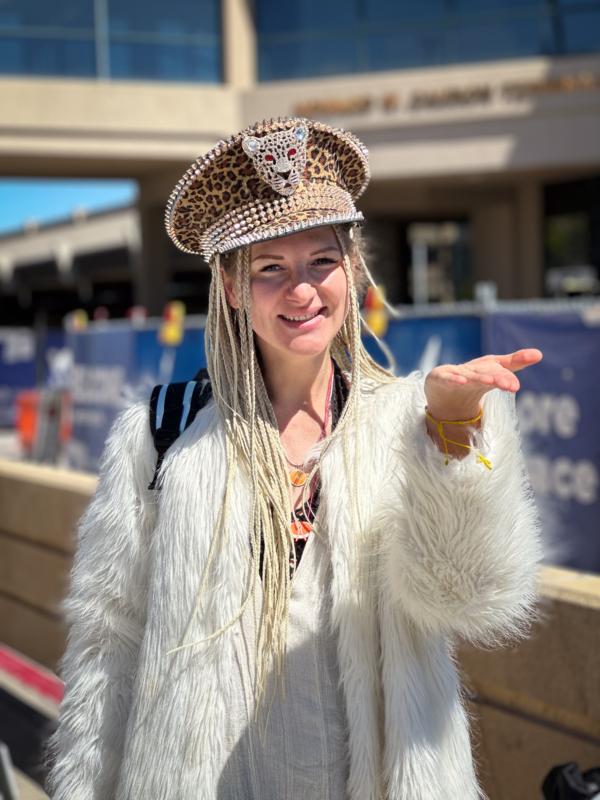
[381,373,542,645]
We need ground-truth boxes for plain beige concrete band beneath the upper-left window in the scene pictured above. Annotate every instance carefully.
[0,77,239,178]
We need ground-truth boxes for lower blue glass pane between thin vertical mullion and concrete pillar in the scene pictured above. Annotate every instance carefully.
[110,42,221,83]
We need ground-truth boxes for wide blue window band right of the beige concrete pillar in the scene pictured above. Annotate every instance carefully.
[256,0,600,80]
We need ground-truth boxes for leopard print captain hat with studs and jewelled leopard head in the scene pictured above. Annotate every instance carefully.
[165,117,369,262]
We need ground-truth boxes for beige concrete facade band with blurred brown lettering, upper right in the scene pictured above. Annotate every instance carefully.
[242,56,600,179]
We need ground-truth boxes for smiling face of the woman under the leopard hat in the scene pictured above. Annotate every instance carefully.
[230,226,348,357]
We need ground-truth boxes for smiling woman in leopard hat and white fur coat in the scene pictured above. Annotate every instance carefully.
[51,119,542,800]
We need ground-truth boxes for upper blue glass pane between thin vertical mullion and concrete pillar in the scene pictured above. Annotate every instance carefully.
[108,0,220,36]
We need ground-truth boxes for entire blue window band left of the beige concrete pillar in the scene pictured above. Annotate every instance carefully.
[0,0,221,83]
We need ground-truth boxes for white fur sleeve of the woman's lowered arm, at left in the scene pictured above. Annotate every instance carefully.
[47,404,155,800]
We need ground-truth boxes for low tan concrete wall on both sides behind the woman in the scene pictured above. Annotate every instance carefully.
[0,460,600,800]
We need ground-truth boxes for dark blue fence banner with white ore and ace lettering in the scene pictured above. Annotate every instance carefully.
[483,311,600,572]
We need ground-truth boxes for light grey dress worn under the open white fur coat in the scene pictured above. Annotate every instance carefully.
[217,532,349,800]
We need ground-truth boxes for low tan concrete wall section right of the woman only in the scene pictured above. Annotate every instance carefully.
[459,567,600,800]
